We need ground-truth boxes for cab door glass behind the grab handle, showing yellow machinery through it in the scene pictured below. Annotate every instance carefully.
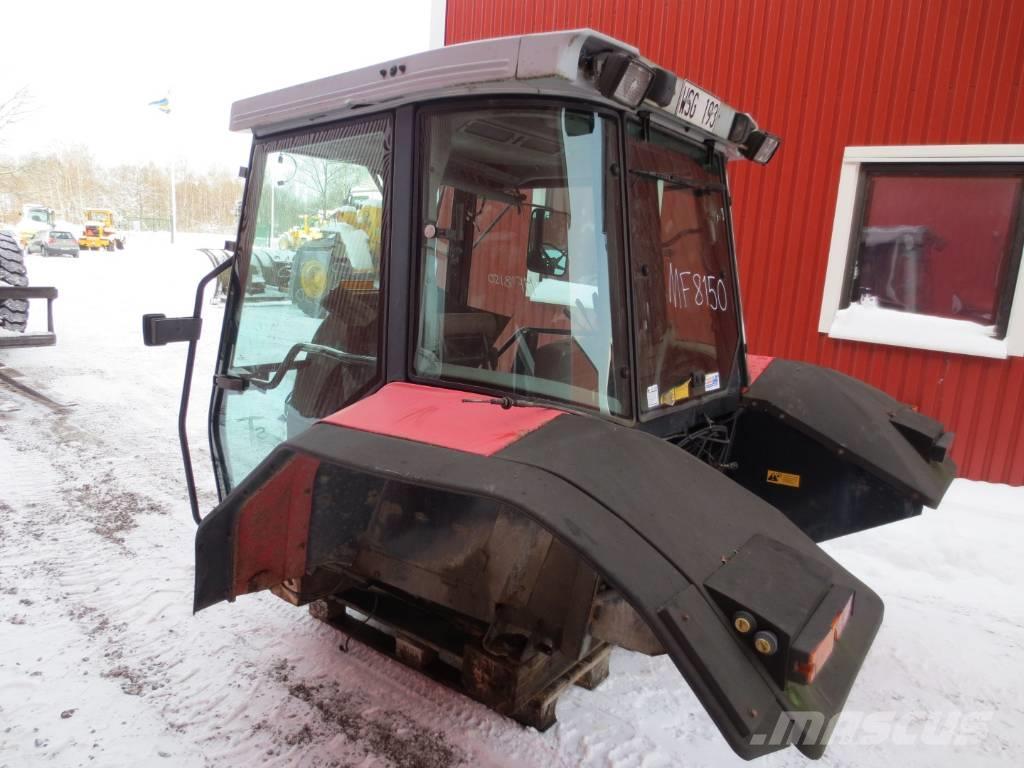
[217,117,391,489]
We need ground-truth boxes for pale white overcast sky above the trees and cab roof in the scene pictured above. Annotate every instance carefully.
[0,0,443,170]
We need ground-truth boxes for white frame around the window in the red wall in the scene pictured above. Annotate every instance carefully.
[818,144,1024,358]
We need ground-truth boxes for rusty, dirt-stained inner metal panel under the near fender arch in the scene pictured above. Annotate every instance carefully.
[311,465,597,659]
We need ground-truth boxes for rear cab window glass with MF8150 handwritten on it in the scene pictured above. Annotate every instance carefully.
[627,124,739,413]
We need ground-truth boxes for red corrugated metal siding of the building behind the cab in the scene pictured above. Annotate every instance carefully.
[445,0,1024,484]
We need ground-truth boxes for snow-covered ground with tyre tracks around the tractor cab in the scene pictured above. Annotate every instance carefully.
[0,237,1024,768]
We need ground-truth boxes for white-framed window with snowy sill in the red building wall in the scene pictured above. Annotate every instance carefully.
[819,144,1024,357]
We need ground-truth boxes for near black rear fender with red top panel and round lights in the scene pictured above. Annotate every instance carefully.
[196,384,882,759]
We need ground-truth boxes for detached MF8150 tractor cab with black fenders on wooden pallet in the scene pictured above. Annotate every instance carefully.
[142,30,955,758]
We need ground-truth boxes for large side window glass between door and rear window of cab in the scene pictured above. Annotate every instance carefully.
[415,106,629,416]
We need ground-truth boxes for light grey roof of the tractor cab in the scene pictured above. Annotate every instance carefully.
[229,29,756,156]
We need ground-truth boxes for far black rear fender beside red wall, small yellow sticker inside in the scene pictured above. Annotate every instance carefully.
[731,358,956,542]
